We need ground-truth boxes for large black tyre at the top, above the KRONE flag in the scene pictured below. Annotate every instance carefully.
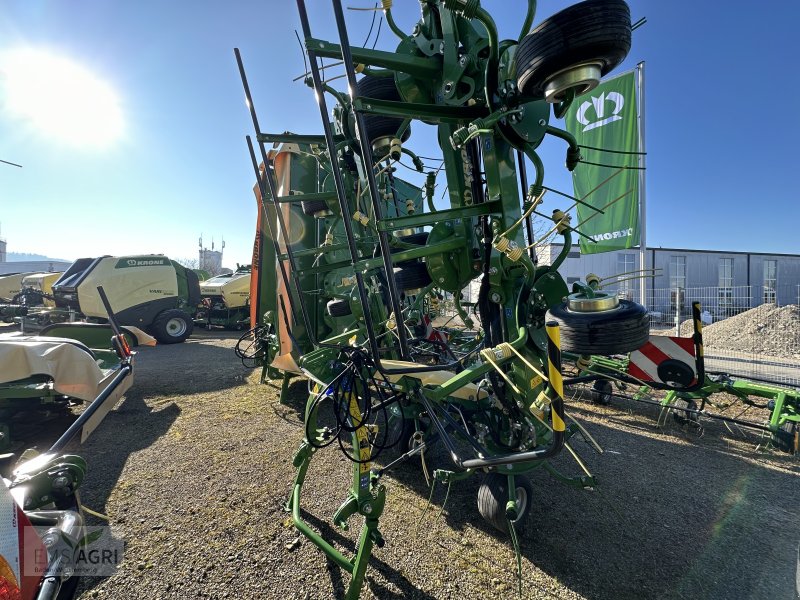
[517,0,631,99]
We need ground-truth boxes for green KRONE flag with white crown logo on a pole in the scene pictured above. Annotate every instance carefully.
[565,71,639,254]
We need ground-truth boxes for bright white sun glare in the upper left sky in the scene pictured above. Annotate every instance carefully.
[0,49,123,146]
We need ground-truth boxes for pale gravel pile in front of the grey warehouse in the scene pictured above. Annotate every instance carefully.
[681,304,800,358]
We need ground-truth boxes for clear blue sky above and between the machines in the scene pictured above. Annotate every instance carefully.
[0,0,800,266]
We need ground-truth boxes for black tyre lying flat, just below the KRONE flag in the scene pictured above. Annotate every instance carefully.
[546,300,650,356]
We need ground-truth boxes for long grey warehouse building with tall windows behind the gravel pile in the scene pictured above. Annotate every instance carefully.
[539,244,800,318]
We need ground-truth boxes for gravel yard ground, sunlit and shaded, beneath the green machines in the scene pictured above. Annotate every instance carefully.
[7,332,800,600]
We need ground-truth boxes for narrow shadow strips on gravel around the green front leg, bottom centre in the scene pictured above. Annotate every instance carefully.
[301,511,436,600]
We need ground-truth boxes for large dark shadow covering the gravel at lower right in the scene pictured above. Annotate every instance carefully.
[412,423,800,600]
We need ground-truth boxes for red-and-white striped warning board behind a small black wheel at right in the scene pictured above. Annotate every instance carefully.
[628,335,697,388]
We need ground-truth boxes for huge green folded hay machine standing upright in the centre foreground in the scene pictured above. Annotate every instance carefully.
[236,0,700,598]
